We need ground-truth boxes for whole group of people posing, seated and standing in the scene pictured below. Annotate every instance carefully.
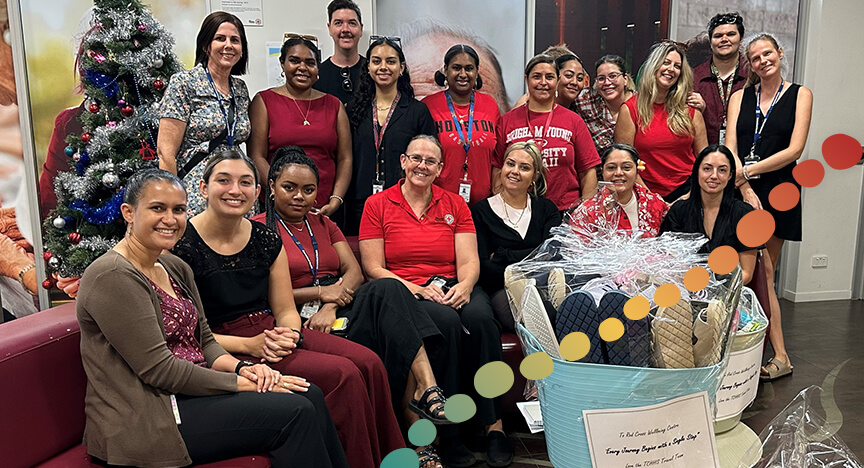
[78,0,812,468]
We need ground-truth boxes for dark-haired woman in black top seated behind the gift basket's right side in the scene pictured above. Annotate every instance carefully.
[660,144,763,285]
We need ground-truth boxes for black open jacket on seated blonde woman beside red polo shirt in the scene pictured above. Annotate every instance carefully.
[471,197,561,294]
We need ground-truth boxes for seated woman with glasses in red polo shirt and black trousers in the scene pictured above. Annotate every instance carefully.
[360,135,513,467]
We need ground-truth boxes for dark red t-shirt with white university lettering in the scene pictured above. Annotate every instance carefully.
[492,104,600,211]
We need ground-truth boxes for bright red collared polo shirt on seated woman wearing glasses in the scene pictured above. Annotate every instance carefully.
[360,179,475,285]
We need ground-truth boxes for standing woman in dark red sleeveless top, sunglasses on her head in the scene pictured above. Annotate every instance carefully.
[248,34,351,225]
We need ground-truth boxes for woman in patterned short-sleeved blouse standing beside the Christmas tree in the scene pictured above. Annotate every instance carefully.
[156,11,251,216]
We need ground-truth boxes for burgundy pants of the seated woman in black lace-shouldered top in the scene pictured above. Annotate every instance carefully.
[213,312,405,468]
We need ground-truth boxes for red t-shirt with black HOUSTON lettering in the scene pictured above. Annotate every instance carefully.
[423,91,501,205]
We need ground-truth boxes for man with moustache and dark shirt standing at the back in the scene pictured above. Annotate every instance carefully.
[313,0,366,104]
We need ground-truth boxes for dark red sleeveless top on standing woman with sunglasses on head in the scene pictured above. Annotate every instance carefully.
[258,89,342,206]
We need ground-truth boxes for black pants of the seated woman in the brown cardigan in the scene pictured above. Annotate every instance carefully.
[177,385,348,468]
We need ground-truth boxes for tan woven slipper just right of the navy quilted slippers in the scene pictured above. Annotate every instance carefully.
[651,298,695,369]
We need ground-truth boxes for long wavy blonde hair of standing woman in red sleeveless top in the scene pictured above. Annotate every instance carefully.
[636,42,694,136]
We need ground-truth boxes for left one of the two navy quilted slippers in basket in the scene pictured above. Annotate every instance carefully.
[555,289,608,364]
